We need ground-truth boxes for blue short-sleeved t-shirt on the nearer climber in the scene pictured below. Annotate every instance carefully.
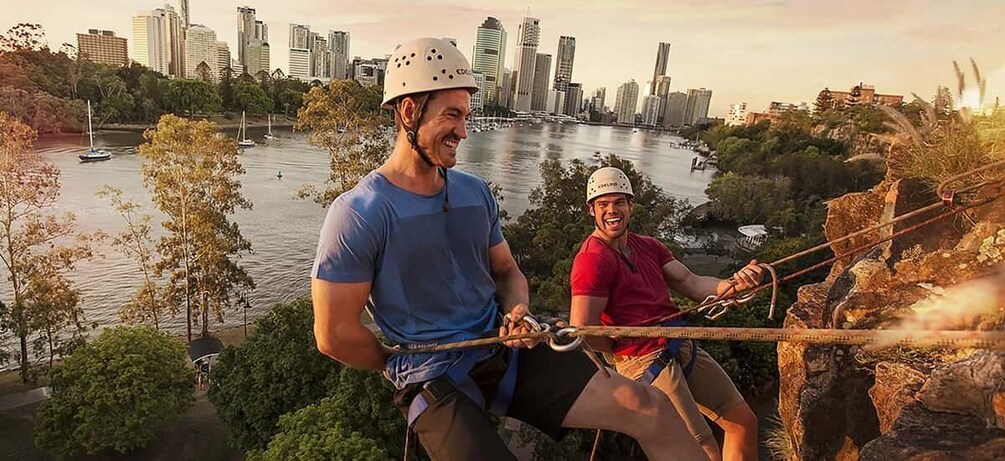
[312,170,503,389]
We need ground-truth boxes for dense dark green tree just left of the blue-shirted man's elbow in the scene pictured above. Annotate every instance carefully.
[209,299,341,451]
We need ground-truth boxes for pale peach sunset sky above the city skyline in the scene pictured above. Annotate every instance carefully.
[0,0,1005,117]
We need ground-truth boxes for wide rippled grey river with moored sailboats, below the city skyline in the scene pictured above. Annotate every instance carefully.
[0,124,713,355]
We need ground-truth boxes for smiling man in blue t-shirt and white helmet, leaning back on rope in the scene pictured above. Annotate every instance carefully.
[312,38,704,460]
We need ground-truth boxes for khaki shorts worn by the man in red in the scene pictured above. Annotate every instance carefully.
[613,341,744,444]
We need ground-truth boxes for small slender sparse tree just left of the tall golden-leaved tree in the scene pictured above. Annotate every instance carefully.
[97,186,171,330]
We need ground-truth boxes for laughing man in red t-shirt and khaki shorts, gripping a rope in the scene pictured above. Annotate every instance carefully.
[570,167,763,460]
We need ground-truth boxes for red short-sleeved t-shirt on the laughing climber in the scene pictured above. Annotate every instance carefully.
[571,232,679,356]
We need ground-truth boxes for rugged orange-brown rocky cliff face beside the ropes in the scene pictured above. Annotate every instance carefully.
[778,175,1005,461]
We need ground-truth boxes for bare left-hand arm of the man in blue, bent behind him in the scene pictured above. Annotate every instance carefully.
[311,278,391,371]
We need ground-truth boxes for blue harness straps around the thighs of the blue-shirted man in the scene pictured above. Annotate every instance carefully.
[408,350,520,428]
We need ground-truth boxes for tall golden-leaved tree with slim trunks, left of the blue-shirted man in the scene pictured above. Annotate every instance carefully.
[140,116,254,340]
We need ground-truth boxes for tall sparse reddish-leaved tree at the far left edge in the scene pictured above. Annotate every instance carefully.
[0,112,90,382]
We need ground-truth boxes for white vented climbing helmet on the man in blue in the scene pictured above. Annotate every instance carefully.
[381,37,478,108]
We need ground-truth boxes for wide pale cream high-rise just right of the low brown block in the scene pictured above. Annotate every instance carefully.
[130,5,185,76]
